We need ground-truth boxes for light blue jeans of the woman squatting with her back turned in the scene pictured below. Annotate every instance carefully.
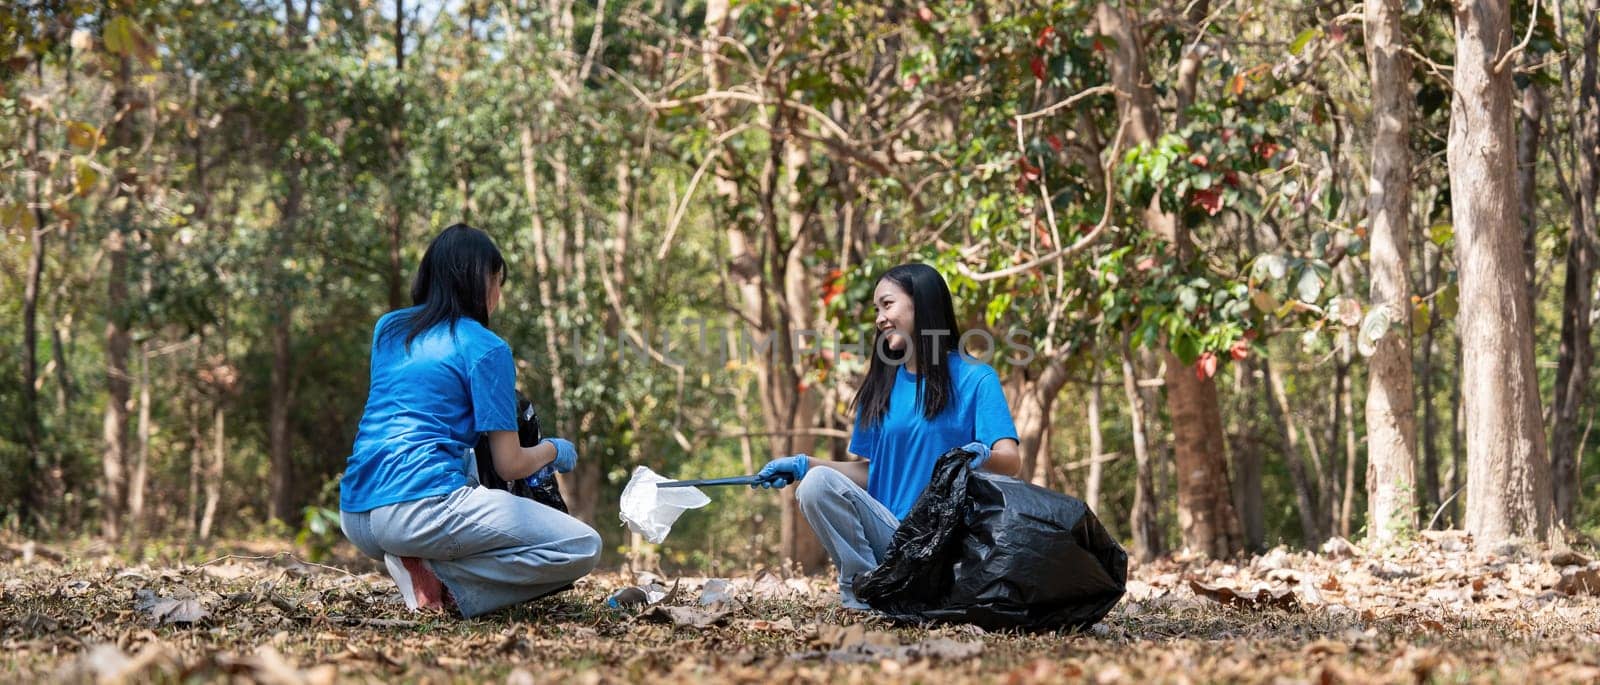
[339,467,600,618]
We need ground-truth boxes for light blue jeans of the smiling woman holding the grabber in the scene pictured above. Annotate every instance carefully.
[795,466,899,610]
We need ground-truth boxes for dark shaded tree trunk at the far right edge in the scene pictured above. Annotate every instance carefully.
[1550,0,1600,527]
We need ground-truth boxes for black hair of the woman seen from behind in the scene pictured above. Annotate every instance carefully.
[382,224,506,349]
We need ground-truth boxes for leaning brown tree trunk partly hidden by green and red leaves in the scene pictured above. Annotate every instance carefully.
[1096,3,1243,557]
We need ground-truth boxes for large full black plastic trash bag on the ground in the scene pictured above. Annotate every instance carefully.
[854,450,1128,631]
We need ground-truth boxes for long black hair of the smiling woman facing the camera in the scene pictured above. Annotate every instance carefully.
[850,264,962,426]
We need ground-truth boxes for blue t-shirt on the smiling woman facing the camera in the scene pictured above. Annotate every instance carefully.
[850,352,1016,519]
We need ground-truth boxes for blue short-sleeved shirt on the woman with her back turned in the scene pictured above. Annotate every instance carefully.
[339,307,517,512]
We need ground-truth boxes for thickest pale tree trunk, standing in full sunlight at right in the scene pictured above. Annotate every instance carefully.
[1448,0,1550,543]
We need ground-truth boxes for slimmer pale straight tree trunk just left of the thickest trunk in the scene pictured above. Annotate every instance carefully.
[1366,0,1416,541]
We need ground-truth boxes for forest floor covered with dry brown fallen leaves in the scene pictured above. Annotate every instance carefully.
[0,533,1600,685]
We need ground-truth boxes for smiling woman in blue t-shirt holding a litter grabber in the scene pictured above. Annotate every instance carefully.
[758,264,1022,610]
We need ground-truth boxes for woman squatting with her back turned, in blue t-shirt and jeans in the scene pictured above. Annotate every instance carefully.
[339,224,600,616]
